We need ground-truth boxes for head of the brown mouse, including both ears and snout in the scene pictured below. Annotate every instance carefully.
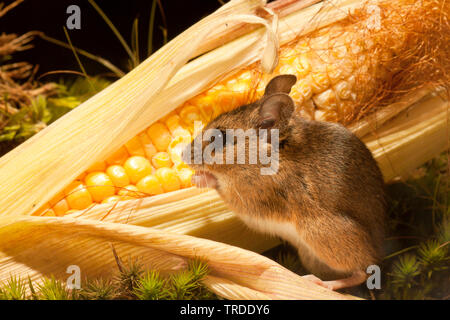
[183,75,297,189]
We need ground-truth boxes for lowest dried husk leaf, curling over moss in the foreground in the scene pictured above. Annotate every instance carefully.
[0,217,356,299]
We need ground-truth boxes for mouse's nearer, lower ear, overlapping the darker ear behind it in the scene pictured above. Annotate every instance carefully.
[258,93,295,129]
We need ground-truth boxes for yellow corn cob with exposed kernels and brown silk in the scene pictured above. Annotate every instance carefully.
[34,1,449,216]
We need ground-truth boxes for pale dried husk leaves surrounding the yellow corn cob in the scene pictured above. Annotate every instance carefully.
[0,0,448,299]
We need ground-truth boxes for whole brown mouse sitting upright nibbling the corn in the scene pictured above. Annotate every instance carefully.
[183,74,387,290]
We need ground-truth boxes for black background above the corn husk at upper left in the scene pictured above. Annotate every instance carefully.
[0,0,221,80]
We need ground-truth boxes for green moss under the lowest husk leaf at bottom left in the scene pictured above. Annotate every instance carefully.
[0,251,218,300]
